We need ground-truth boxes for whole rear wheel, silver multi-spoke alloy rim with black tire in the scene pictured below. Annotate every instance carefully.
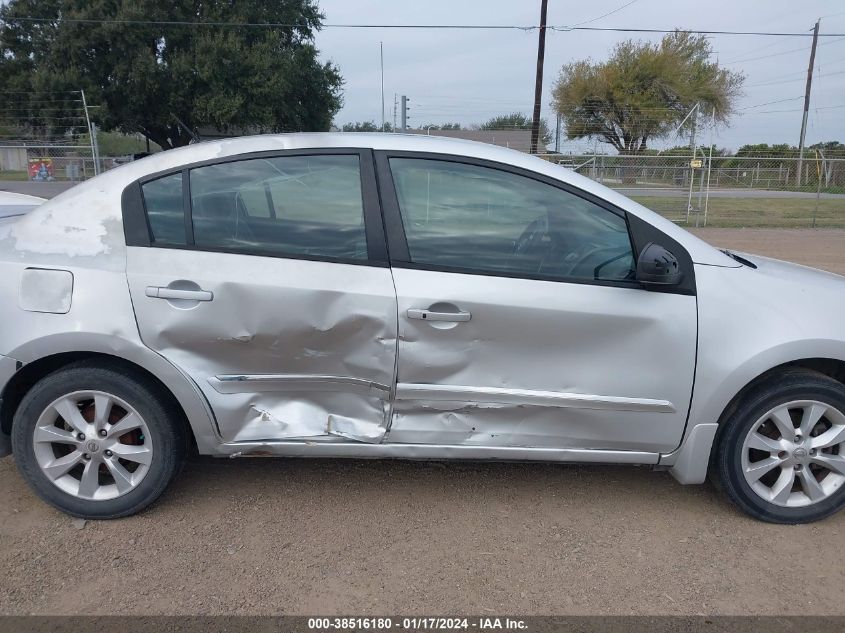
[12,363,186,519]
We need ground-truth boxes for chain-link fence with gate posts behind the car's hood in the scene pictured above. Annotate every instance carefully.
[543,149,845,228]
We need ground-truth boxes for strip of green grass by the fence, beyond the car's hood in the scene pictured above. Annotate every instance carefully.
[632,196,845,228]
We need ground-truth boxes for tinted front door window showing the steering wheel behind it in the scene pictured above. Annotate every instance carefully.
[390,158,634,280]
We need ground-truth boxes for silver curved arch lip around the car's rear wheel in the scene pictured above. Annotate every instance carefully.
[0,334,220,453]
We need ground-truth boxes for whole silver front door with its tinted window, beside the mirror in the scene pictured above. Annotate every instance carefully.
[377,153,697,452]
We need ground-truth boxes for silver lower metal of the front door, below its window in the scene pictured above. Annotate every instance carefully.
[389,268,696,451]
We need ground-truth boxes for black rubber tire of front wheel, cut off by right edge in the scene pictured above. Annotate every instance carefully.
[711,368,845,524]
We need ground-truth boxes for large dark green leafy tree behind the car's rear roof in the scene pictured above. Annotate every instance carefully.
[0,0,342,148]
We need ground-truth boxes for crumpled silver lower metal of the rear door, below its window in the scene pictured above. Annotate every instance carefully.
[127,247,396,442]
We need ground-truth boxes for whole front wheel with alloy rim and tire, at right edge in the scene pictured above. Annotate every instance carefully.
[715,369,845,523]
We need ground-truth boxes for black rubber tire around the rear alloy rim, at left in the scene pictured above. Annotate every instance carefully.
[12,361,187,519]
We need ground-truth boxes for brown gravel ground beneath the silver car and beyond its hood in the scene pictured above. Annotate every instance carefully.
[0,229,845,615]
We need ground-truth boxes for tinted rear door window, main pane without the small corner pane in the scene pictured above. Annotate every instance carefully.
[191,156,367,259]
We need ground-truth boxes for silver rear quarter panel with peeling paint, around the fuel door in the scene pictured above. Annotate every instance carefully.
[0,185,218,452]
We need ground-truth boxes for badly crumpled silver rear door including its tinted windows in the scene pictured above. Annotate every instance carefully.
[124,150,396,442]
